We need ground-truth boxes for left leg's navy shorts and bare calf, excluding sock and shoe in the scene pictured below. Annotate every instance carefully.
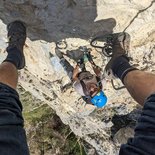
[0,51,29,155]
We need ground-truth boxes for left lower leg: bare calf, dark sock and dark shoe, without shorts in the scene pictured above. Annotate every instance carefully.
[0,21,26,89]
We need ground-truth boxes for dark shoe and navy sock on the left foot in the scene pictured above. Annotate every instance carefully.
[6,21,26,69]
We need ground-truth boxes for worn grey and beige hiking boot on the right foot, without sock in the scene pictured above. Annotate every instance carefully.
[105,32,130,78]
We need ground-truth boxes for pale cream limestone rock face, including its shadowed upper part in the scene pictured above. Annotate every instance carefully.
[0,0,155,155]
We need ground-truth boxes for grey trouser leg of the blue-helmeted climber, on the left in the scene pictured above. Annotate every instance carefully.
[60,58,74,80]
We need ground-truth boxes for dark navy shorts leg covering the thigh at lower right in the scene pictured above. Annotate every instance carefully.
[119,94,155,155]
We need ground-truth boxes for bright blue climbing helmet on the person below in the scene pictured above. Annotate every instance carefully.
[91,91,107,108]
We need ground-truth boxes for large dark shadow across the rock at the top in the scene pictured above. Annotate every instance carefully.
[0,0,116,42]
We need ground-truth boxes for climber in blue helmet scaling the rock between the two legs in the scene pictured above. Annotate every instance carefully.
[55,47,107,108]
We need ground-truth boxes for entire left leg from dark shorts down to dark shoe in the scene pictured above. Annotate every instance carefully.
[0,22,29,155]
